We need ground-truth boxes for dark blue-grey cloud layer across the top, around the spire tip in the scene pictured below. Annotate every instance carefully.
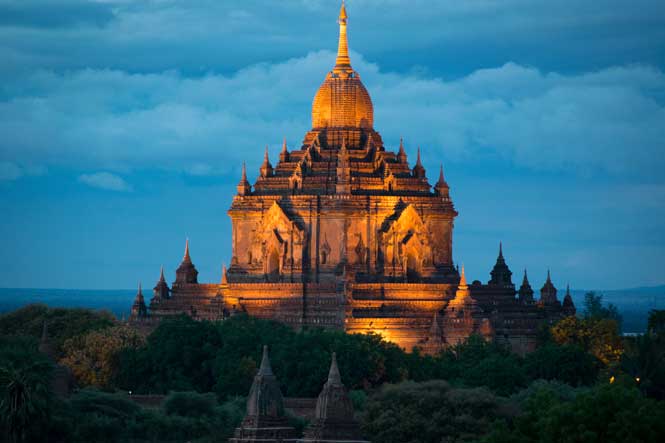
[0,0,665,76]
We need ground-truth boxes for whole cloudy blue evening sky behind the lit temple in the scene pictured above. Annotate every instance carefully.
[0,0,665,289]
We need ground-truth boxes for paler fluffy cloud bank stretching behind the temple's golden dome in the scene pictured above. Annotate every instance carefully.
[0,51,665,182]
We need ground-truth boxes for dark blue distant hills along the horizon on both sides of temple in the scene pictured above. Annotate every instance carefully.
[0,285,665,332]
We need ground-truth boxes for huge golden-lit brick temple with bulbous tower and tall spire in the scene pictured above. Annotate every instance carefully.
[131,1,575,353]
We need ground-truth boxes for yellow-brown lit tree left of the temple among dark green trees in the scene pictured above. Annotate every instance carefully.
[60,325,145,388]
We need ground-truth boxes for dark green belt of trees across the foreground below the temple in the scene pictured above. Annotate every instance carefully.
[0,294,665,443]
